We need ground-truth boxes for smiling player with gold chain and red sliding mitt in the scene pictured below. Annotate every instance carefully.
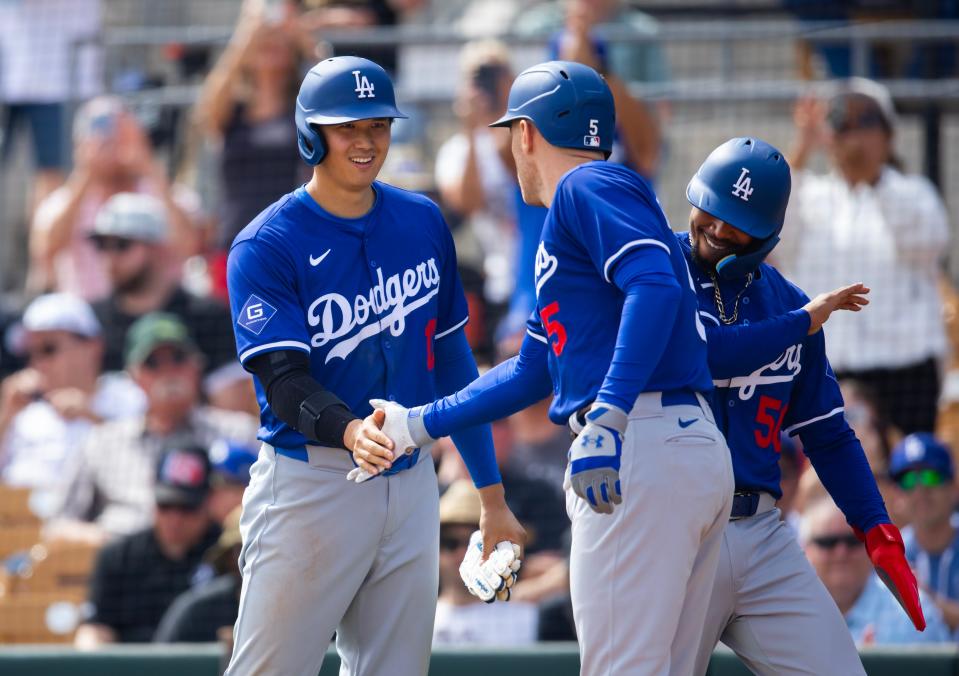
[678,138,925,676]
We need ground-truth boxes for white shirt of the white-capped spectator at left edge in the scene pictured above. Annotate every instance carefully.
[0,373,146,512]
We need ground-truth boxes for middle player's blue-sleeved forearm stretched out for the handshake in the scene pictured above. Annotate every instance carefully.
[423,336,553,439]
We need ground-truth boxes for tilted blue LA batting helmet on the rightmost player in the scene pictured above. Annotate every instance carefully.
[686,137,792,278]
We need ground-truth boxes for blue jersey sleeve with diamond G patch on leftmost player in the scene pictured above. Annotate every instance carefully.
[227,239,310,364]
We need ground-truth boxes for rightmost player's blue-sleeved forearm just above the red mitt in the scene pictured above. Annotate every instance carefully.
[799,414,892,532]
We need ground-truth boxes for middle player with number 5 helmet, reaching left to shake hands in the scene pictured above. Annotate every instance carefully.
[352,61,733,675]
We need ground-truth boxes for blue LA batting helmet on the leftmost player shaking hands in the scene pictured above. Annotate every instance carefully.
[296,56,406,165]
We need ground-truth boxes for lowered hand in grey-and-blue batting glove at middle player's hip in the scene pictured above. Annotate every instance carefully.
[567,402,628,514]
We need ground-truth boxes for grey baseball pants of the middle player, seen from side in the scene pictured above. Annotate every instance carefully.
[566,392,733,676]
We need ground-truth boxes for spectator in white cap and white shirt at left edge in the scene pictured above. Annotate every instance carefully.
[0,293,145,506]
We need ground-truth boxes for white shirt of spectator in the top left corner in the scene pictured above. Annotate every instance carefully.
[0,0,102,103]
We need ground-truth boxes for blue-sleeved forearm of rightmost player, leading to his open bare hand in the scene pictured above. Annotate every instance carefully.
[706,309,809,378]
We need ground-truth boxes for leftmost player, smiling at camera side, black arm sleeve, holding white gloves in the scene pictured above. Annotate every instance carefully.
[227,56,523,676]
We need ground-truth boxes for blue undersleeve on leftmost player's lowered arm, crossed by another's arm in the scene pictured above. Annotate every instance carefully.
[436,329,502,488]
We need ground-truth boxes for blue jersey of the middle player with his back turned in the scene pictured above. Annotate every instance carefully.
[527,161,712,424]
